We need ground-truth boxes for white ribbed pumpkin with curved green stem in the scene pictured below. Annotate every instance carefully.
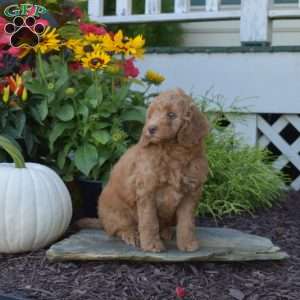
[0,136,72,253]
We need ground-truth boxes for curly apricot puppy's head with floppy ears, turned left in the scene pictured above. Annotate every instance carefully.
[142,89,208,145]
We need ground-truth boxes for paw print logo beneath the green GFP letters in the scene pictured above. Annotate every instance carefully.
[4,16,45,47]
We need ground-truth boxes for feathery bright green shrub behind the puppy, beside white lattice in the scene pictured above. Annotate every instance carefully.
[197,96,286,218]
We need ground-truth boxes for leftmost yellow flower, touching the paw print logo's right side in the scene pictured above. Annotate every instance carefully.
[33,27,62,54]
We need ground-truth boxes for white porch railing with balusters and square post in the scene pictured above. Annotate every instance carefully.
[89,0,300,44]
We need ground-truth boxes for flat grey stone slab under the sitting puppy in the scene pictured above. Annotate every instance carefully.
[47,227,288,262]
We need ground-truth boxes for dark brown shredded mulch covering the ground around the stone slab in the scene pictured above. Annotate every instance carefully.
[0,192,300,300]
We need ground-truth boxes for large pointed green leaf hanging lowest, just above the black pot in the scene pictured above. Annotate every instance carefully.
[75,144,98,176]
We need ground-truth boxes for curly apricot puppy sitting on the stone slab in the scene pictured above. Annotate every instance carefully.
[77,89,209,252]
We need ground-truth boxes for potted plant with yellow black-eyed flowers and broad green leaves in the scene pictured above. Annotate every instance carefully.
[23,24,164,215]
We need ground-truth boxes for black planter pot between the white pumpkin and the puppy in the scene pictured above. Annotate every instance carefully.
[77,178,102,218]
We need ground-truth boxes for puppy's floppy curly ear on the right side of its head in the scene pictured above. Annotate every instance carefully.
[177,103,209,145]
